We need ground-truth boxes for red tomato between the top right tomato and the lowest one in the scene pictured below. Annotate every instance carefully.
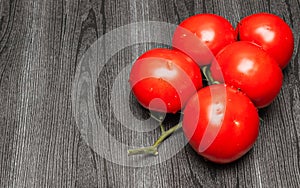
[210,41,283,108]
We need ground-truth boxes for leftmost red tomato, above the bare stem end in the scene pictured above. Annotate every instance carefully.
[129,48,202,113]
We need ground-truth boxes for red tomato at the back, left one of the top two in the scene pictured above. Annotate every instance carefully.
[173,14,236,66]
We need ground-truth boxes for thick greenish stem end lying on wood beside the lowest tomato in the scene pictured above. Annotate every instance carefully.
[128,122,182,155]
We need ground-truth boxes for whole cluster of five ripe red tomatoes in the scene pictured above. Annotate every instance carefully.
[129,13,294,163]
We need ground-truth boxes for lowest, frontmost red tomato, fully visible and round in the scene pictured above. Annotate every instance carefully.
[182,84,259,163]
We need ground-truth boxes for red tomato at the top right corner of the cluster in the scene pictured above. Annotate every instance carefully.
[237,13,294,69]
